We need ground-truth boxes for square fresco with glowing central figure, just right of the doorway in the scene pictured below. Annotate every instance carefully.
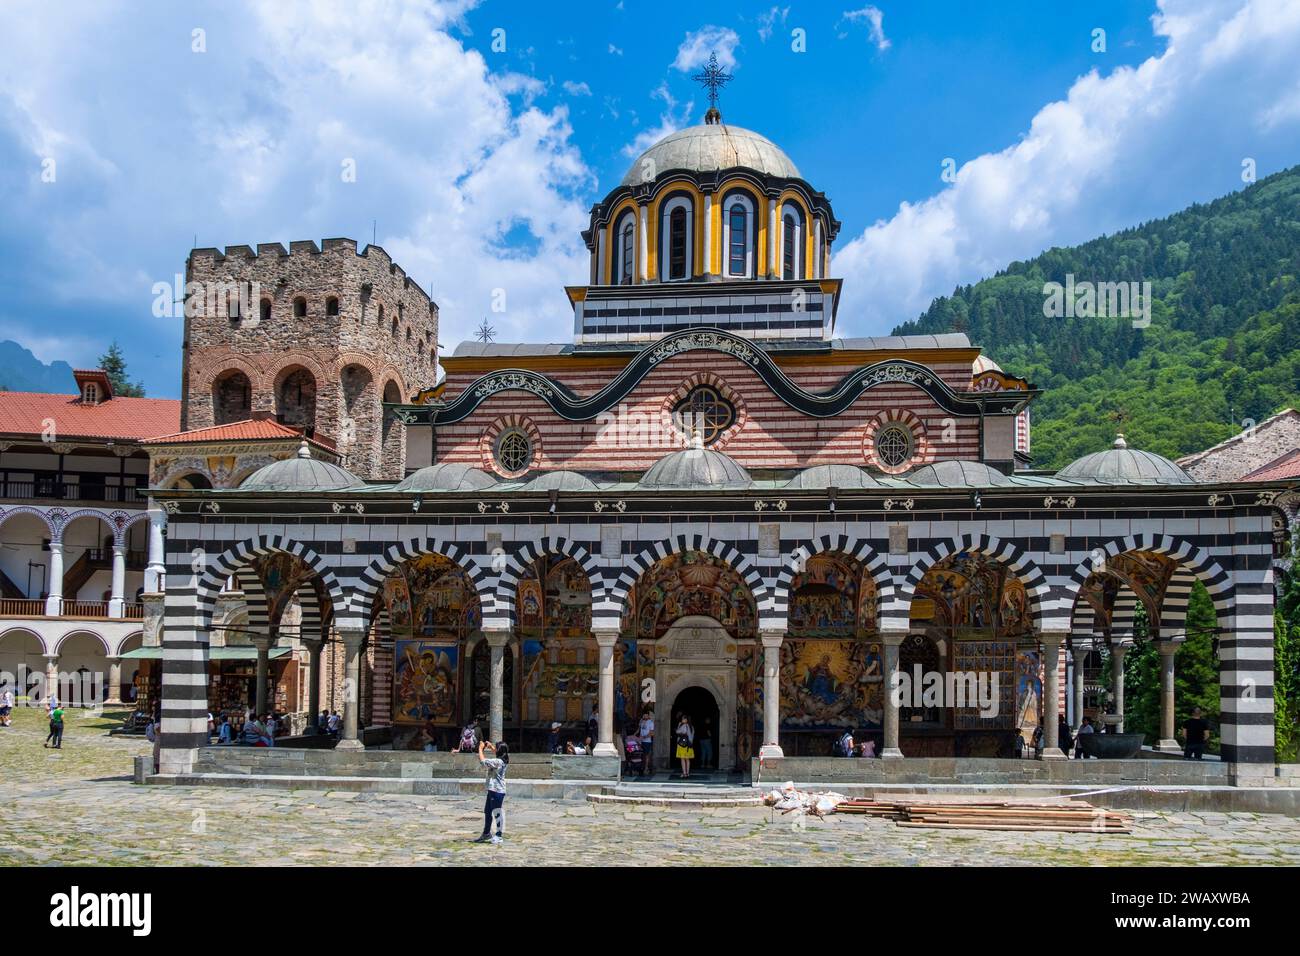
[781,640,884,730]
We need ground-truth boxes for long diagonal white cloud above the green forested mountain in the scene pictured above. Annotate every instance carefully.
[835,0,1300,332]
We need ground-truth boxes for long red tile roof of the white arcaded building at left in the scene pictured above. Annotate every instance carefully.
[0,392,181,441]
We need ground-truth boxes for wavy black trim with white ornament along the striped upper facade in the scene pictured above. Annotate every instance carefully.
[384,326,1039,425]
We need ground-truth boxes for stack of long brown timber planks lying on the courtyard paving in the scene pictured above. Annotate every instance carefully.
[835,797,1132,834]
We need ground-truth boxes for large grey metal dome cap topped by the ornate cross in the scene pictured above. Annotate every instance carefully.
[619,122,802,186]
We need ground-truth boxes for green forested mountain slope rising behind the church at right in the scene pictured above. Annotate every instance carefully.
[894,166,1300,468]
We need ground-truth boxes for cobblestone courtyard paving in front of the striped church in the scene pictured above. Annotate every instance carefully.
[0,710,1300,866]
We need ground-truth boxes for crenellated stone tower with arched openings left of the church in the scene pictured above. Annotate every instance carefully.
[181,239,438,479]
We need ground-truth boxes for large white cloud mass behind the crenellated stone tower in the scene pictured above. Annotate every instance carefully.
[0,0,594,385]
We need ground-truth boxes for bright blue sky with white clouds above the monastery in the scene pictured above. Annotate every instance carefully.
[0,0,1300,395]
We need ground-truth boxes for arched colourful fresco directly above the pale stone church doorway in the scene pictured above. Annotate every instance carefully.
[624,551,758,640]
